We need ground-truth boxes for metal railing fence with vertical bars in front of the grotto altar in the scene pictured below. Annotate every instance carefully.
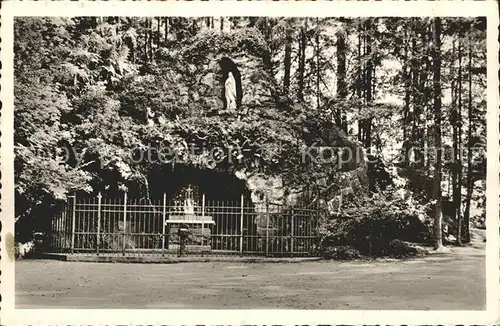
[50,194,319,257]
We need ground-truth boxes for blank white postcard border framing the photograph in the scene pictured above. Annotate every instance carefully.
[0,0,500,325]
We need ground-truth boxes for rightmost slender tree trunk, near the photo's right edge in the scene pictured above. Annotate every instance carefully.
[463,26,474,243]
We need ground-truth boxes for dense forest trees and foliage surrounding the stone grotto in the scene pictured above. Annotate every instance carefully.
[14,17,486,252]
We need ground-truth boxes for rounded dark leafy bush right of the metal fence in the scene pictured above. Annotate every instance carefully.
[318,190,431,257]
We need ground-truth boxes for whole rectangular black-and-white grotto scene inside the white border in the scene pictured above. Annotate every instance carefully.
[2,3,499,323]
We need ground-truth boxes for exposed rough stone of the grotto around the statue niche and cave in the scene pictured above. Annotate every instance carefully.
[158,29,368,211]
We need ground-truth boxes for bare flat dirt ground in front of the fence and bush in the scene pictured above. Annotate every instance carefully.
[16,230,486,310]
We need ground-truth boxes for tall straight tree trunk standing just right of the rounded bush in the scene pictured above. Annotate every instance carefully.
[433,17,443,249]
